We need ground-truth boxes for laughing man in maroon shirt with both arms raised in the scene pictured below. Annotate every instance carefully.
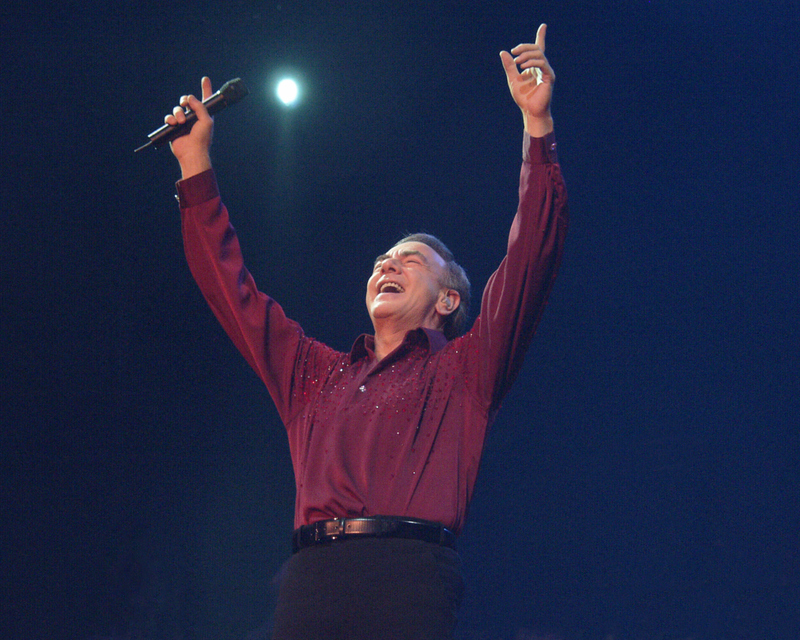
[165,25,567,640]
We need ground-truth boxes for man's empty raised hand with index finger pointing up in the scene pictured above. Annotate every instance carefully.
[500,24,556,137]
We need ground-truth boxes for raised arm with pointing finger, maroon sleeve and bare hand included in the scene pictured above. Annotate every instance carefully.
[461,25,568,410]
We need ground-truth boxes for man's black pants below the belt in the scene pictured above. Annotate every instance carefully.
[272,538,464,640]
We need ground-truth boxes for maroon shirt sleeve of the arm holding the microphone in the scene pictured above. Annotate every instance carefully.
[176,170,337,424]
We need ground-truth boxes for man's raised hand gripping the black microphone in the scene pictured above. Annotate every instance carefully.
[164,77,214,179]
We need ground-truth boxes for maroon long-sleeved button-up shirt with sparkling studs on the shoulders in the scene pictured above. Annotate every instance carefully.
[177,134,567,533]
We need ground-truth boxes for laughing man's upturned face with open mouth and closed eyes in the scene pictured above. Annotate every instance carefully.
[367,242,446,330]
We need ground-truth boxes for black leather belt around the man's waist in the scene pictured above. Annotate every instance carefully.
[292,516,456,553]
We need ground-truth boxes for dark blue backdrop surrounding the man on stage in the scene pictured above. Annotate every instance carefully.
[0,0,800,640]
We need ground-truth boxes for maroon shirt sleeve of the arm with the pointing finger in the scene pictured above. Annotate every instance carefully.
[465,133,568,411]
